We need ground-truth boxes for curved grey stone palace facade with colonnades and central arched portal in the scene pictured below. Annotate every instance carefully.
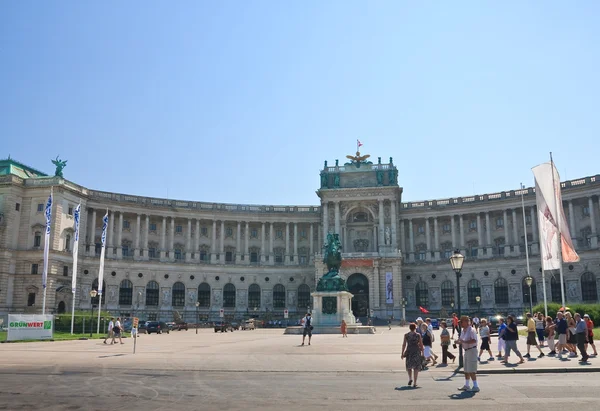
[0,157,600,321]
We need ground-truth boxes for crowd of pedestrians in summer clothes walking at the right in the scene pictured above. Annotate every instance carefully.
[402,311,598,392]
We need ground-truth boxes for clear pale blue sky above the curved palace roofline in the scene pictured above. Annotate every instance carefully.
[0,0,600,204]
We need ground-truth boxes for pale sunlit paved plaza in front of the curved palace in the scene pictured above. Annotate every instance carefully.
[0,327,600,411]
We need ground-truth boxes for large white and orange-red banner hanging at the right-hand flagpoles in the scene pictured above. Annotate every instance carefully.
[531,162,579,270]
